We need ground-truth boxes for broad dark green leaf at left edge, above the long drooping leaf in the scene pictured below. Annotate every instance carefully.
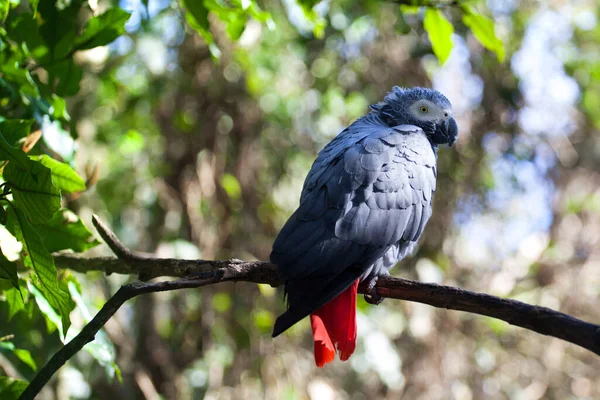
[4,159,60,224]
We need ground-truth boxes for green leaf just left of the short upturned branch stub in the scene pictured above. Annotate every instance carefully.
[35,209,100,253]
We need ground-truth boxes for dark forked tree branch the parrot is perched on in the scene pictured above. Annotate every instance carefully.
[20,216,600,400]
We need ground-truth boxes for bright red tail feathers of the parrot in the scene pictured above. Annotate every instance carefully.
[310,279,359,367]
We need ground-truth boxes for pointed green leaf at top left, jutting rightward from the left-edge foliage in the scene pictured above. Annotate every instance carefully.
[74,7,131,50]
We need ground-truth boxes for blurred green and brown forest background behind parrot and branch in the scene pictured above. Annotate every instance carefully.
[0,0,600,400]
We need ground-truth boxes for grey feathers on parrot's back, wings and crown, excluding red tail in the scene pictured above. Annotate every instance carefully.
[271,88,449,335]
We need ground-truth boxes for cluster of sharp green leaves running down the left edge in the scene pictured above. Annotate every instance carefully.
[0,0,124,390]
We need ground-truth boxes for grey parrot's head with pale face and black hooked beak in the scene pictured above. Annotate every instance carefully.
[371,86,458,146]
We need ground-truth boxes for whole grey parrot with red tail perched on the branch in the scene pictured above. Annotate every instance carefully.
[270,86,458,367]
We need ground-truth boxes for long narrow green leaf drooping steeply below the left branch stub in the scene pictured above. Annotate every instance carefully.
[6,207,75,332]
